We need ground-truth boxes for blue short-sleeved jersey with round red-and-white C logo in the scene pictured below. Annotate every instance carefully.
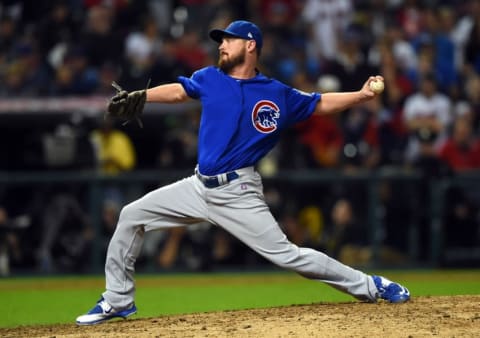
[178,66,320,176]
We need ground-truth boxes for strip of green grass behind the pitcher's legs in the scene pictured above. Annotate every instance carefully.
[0,270,480,327]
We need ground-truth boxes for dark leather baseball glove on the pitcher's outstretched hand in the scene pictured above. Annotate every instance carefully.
[106,80,150,128]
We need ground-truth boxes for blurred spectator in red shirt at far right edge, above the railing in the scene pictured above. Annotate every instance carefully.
[439,116,480,173]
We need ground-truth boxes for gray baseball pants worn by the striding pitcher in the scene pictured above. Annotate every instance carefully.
[103,167,377,309]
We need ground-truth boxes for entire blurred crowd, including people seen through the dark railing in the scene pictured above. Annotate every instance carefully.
[0,0,480,272]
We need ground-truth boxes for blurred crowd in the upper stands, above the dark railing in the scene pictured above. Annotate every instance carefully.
[0,0,480,170]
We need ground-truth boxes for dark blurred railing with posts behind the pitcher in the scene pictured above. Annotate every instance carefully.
[0,170,480,271]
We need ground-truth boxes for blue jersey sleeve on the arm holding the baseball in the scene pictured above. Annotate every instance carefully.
[286,88,321,123]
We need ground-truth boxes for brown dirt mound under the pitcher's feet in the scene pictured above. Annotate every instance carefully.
[0,295,480,338]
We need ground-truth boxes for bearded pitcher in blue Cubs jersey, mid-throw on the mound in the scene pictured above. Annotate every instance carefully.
[76,21,410,325]
